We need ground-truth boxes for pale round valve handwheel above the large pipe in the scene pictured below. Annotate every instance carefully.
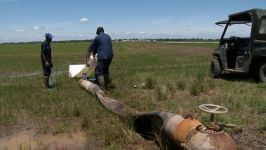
[199,104,228,114]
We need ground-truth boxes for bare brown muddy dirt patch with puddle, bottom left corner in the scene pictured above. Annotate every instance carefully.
[0,109,88,150]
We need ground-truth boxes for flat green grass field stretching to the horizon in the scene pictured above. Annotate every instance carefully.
[0,42,266,149]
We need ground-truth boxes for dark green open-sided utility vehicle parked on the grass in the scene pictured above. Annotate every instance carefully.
[210,9,266,82]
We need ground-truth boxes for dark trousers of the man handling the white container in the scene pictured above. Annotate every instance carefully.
[95,59,112,79]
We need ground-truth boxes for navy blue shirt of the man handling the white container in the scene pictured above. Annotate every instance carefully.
[90,32,113,60]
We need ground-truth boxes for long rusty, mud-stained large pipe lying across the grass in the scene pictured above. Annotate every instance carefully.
[80,80,236,150]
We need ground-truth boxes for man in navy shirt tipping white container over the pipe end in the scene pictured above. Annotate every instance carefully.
[89,27,113,90]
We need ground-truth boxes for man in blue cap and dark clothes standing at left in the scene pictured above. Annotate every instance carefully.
[41,33,53,88]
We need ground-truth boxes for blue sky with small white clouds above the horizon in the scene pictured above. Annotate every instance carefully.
[0,0,266,43]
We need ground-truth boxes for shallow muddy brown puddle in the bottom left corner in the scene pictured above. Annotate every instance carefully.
[0,129,86,150]
